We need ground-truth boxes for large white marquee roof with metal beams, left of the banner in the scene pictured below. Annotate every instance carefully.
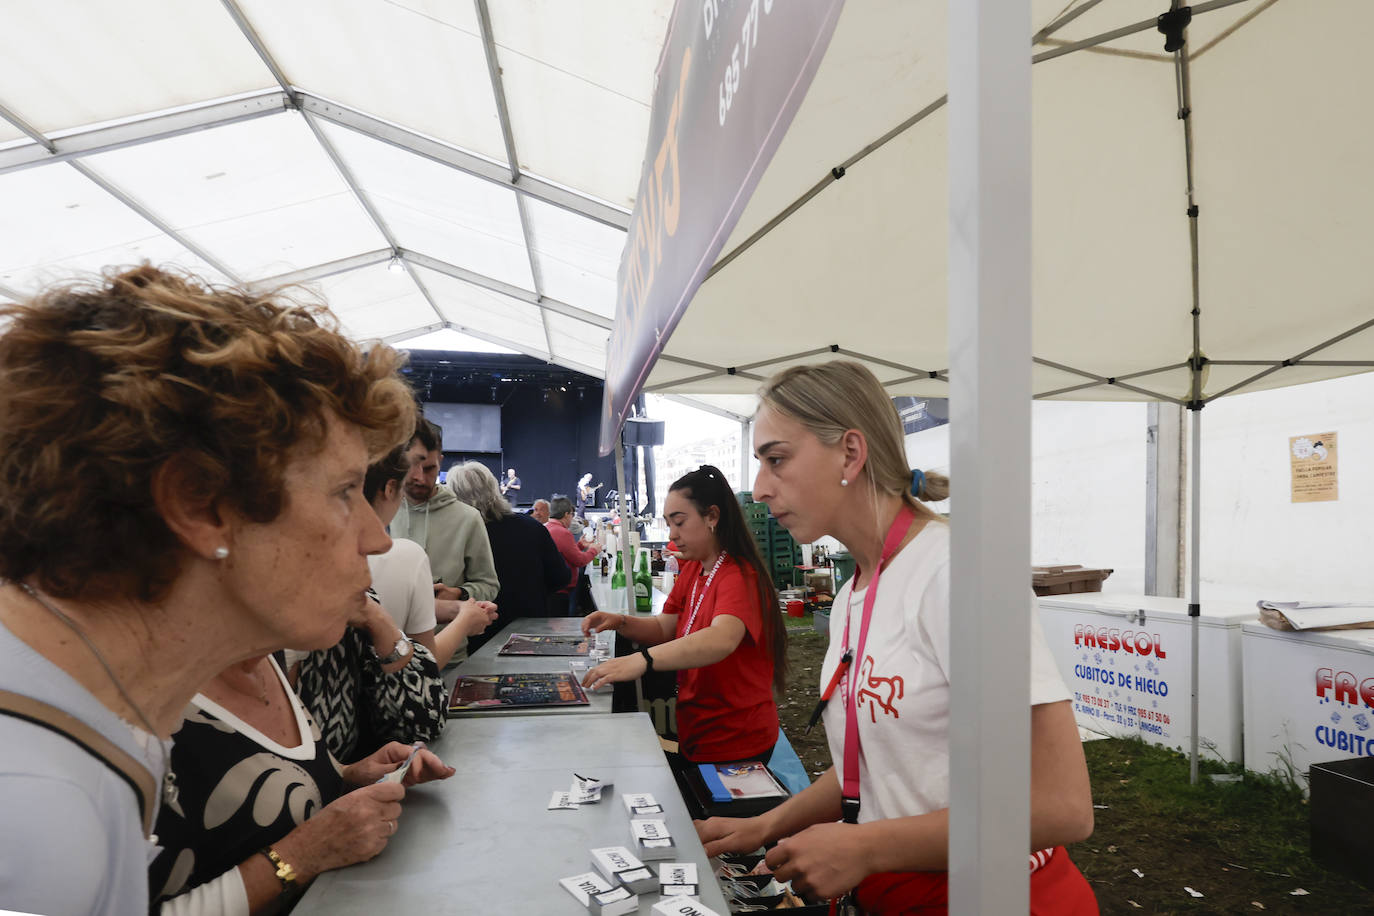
[0,0,747,412]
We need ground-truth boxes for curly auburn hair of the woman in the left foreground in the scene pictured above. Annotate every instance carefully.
[0,264,415,602]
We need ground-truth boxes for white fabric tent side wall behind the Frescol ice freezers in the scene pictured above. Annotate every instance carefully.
[907,374,1374,603]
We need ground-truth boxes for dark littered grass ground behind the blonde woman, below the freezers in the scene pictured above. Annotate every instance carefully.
[779,631,1374,916]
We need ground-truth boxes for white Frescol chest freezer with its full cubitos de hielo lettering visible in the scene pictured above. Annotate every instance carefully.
[1040,592,1259,761]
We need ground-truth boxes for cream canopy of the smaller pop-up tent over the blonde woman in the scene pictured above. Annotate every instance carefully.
[647,0,1374,400]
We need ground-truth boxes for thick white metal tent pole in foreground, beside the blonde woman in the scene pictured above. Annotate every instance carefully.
[948,0,1031,916]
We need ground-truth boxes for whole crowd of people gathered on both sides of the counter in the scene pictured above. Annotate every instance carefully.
[0,266,1096,916]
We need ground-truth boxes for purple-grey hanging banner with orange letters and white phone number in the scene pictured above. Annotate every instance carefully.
[600,0,844,455]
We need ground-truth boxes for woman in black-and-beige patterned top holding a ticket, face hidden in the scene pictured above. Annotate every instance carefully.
[148,655,453,916]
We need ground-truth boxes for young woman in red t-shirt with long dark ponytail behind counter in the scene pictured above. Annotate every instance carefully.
[583,464,786,764]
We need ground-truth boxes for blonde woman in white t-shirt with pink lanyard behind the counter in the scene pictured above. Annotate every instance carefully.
[698,361,1098,916]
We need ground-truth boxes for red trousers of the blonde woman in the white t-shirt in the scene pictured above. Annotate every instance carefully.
[857,846,1098,916]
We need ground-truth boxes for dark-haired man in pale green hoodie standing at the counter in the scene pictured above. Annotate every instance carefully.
[392,419,500,650]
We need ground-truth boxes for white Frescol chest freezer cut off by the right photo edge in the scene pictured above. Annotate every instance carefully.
[1241,623,1374,786]
